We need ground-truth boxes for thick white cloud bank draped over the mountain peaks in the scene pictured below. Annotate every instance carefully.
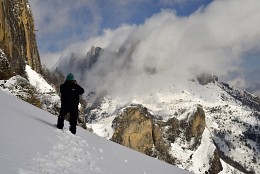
[34,0,260,96]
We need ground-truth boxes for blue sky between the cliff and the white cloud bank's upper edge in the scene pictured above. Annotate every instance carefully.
[29,0,211,53]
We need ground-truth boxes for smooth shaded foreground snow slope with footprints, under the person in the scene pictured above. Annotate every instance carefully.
[0,91,191,174]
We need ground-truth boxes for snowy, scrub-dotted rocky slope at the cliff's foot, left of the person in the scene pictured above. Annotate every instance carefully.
[0,65,60,115]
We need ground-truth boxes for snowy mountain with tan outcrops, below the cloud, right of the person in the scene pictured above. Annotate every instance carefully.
[55,45,260,174]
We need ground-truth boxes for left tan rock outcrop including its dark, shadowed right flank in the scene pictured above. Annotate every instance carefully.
[111,105,174,164]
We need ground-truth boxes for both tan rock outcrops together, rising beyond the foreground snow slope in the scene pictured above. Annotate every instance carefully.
[111,105,222,174]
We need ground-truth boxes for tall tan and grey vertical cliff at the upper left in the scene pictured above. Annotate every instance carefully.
[0,0,42,79]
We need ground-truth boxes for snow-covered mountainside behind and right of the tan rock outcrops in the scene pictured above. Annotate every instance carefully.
[88,75,260,173]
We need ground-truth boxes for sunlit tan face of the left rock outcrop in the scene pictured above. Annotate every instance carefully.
[112,107,154,154]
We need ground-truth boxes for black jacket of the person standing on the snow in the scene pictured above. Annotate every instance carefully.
[60,80,84,109]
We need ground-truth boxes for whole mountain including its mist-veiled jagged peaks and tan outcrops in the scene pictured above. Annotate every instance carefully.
[53,42,260,174]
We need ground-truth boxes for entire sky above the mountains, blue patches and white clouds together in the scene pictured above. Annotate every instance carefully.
[29,0,260,95]
